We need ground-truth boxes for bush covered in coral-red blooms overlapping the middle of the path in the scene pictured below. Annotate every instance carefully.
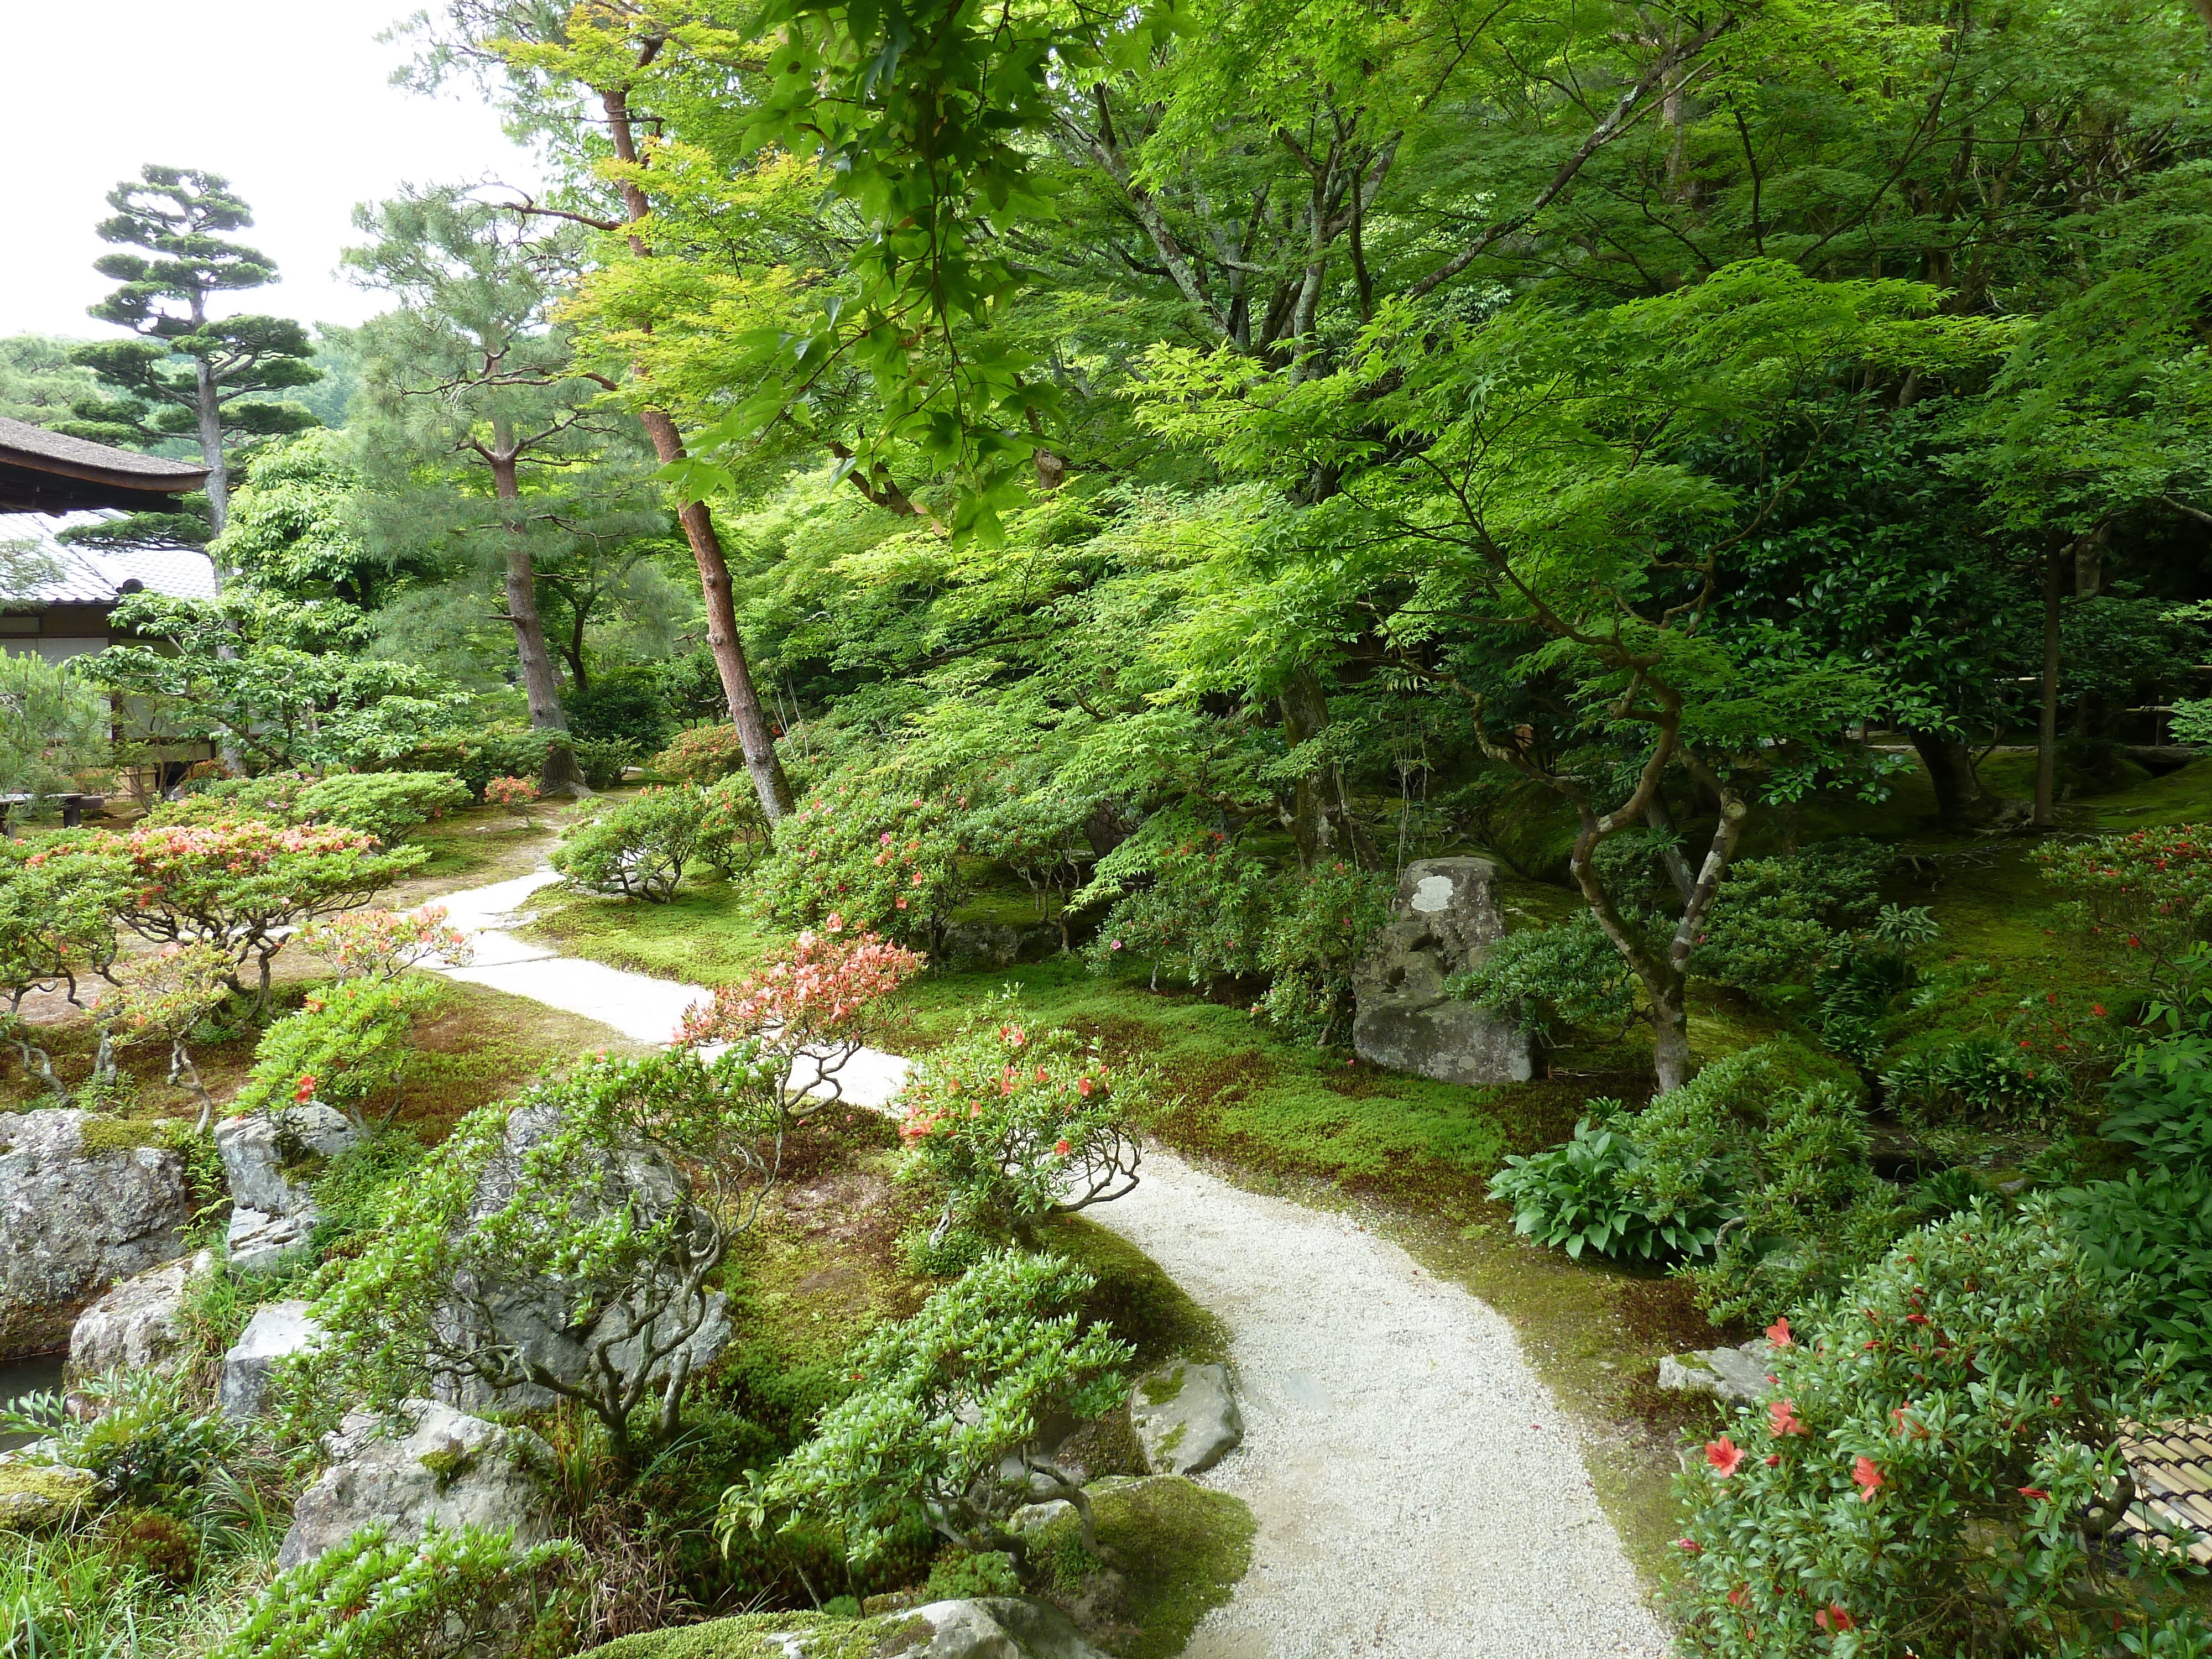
[675,916,927,1104]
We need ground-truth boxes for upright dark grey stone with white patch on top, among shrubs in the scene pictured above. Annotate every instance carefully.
[1352,858,1535,1084]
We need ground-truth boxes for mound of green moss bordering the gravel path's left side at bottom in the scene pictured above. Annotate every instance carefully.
[1060,1475,1259,1659]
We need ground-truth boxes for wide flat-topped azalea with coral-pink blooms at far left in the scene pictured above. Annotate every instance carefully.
[84,818,429,1009]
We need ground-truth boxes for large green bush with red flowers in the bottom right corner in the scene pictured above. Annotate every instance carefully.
[1677,1208,2208,1659]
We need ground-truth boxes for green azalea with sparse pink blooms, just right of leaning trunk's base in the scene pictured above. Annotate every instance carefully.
[752,785,967,949]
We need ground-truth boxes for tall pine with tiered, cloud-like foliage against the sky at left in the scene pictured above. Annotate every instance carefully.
[62,164,323,542]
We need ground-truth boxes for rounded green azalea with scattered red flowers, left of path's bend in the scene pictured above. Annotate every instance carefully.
[896,995,1148,1245]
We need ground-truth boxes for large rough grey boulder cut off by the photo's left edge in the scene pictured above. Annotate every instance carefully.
[0,1108,192,1358]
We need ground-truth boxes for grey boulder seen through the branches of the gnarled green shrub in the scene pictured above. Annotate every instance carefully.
[434,1106,730,1411]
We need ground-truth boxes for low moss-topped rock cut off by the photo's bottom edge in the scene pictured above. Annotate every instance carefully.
[584,1595,1106,1659]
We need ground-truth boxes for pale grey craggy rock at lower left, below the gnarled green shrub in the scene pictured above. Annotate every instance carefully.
[276,1400,553,1568]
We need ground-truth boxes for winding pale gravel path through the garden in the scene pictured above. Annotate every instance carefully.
[416,872,1668,1659]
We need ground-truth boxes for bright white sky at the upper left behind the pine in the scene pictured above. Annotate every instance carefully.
[0,0,538,338]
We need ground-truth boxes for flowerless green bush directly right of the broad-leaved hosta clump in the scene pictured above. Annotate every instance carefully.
[1628,1042,1907,1321]
